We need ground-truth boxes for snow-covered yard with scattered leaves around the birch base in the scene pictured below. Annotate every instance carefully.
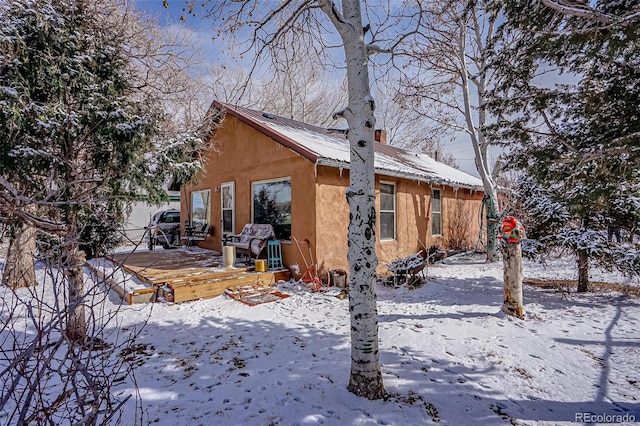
[1,251,640,426]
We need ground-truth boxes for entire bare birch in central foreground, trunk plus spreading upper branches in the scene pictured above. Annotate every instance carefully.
[186,0,424,399]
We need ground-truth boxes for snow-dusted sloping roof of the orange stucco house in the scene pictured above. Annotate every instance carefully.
[214,102,483,190]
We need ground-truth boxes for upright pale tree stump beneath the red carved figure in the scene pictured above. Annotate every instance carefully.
[502,242,524,319]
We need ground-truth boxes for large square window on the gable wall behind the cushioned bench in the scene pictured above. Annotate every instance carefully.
[251,178,291,240]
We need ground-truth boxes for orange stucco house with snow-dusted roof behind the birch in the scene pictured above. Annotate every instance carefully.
[181,101,483,273]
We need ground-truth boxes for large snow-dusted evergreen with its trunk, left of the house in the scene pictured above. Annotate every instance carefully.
[0,0,205,341]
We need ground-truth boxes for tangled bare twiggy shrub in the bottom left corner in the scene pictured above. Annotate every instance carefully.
[0,253,150,425]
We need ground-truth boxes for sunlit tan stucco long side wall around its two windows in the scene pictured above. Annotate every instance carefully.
[316,167,482,273]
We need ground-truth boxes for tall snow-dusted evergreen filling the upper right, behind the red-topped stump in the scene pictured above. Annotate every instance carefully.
[491,1,640,291]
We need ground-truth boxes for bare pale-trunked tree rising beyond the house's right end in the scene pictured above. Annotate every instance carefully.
[404,0,508,261]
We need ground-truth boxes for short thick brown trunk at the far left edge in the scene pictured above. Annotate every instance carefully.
[2,223,37,289]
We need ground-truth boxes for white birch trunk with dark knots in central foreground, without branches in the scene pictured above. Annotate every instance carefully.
[319,0,386,399]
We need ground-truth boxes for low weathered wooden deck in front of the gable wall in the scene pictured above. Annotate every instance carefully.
[105,250,289,303]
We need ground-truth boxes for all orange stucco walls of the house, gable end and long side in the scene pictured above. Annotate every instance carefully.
[181,110,482,273]
